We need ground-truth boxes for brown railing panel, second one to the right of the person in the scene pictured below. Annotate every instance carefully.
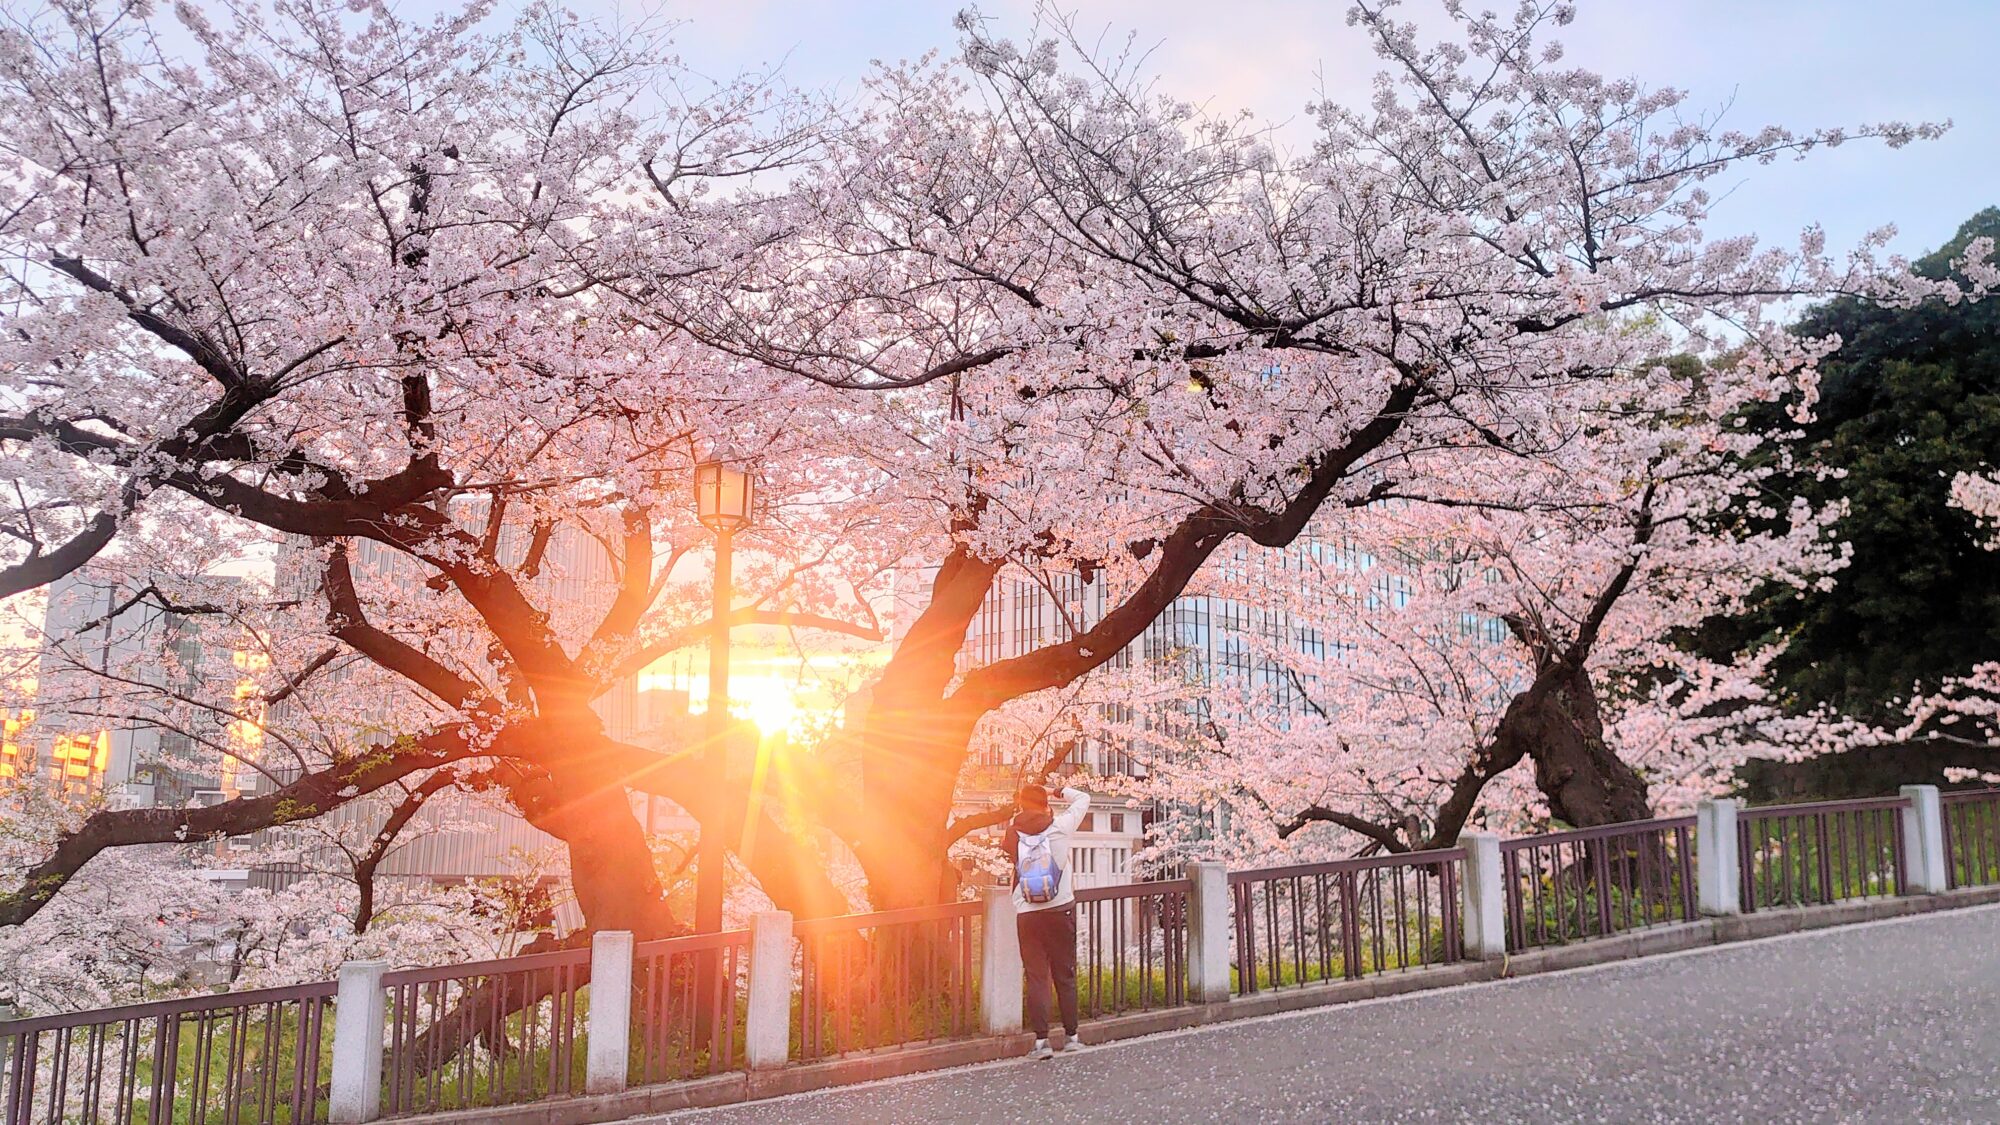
[1228,847,1466,995]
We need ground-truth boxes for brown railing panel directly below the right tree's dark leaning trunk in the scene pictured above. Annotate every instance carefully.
[1500,817,1696,951]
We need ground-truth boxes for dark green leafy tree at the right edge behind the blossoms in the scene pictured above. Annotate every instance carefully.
[1706,208,2000,721]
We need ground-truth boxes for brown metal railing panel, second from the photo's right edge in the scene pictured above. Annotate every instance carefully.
[1736,797,1910,913]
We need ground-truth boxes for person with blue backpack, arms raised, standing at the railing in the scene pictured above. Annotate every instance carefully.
[1000,785,1090,1059]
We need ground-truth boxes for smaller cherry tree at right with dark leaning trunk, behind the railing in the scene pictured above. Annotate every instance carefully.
[1104,350,1842,859]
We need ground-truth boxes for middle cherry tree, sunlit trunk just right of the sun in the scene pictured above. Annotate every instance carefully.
[652,4,1984,907]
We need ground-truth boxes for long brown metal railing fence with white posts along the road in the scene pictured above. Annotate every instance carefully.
[0,787,1968,1125]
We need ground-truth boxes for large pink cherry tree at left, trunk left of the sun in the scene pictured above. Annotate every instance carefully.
[0,2,894,933]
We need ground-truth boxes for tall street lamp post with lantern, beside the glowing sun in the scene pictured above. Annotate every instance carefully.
[694,460,756,933]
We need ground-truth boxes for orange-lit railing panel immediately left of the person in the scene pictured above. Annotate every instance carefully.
[792,903,984,1059]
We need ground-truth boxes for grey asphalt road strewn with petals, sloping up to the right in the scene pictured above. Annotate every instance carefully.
[654,909,2000,1125]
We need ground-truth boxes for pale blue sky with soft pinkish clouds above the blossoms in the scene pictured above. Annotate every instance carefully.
[648,0,2000,252]
